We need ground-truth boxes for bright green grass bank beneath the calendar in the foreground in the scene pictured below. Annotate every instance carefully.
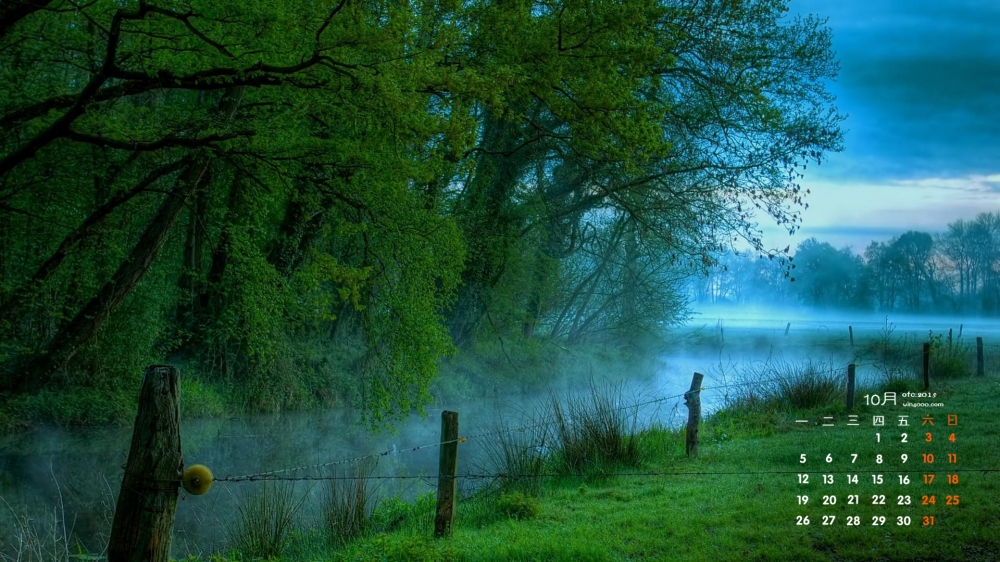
[189,372,1000,562]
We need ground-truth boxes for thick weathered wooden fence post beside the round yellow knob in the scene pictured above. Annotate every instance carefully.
[108,365,184,562]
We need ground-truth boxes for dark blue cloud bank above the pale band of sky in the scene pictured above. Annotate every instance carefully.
[791,0,1000,181]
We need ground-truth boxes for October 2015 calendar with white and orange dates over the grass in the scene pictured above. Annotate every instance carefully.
[792,392,975,529]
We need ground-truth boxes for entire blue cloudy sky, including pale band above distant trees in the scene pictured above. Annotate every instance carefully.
[761,0,1000,253]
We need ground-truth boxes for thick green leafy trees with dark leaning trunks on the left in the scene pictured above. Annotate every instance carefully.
[0,1,475,420]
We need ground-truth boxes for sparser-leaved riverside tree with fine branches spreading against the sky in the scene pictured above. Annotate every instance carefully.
[442,1,840,342]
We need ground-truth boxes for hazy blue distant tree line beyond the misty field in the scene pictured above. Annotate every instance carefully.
[688,212,1000,316]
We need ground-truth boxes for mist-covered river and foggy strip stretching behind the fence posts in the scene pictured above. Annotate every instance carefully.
[0,306,1000,556]
